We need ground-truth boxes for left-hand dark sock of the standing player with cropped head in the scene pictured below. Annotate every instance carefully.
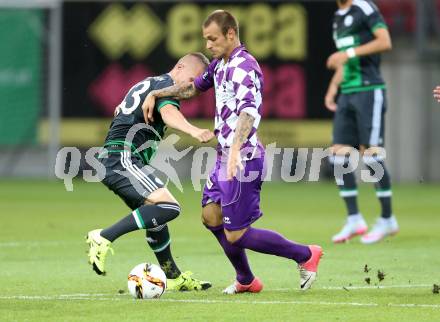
[329,155,359,216]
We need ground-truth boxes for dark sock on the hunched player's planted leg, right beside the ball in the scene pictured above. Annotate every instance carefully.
[147,225,180,278]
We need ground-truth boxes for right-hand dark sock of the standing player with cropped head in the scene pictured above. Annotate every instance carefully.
[364,156,393,218]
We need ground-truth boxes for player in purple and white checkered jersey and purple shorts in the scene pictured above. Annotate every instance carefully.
[143,10,322,294]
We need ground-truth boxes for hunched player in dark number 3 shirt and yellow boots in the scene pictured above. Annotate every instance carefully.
[87,53,214,291]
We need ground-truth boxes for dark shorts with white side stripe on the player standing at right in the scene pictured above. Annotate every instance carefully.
[333,89,386,148]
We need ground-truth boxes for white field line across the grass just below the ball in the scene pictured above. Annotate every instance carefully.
[0,294,440,309]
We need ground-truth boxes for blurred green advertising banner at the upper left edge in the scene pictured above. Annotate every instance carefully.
[0,9,44,146]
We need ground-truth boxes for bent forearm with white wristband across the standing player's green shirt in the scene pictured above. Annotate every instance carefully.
[327,28,393,69]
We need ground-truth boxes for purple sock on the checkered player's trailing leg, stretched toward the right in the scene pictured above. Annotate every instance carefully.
[234,227,312,264]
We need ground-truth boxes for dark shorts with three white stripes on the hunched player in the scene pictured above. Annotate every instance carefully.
[100,151,164,210]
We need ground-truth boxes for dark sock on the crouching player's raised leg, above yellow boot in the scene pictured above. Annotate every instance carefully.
[101,202,180,242]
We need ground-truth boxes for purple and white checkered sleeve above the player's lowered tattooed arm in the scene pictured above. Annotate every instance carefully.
[232,66,262,119]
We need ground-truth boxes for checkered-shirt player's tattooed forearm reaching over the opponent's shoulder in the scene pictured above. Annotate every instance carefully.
[142,82,199,123]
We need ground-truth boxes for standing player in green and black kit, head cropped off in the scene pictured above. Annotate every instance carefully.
[325,0,399,244]
